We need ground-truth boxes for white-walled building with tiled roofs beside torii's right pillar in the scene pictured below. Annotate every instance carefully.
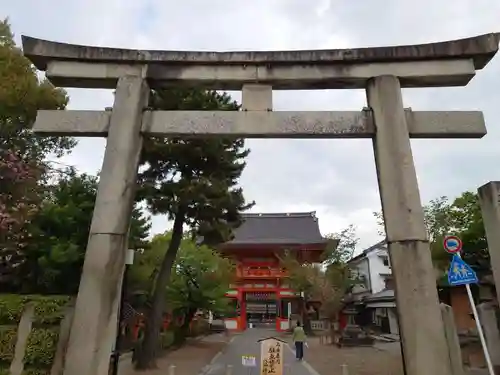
[349,240,399,334]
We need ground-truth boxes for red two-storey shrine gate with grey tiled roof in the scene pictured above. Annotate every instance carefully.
[219,212,328,331]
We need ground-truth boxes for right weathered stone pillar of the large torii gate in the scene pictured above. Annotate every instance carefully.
[366,76,451,375]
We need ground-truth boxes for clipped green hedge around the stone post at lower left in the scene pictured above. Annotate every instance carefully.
[0,295,71,375]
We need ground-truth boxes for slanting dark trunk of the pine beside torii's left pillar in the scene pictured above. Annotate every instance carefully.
[136,209,185,370]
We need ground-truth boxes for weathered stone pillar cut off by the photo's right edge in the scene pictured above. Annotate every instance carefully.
[477,181,500,302]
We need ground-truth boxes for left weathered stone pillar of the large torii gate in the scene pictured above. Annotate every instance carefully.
[64,73,149,375]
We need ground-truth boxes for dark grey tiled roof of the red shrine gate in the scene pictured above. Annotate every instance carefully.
[224,212,327,246]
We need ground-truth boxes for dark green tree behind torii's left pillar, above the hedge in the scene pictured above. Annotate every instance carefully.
[4,168,151,294]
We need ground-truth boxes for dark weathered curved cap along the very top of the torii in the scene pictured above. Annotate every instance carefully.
[22,33,500,70]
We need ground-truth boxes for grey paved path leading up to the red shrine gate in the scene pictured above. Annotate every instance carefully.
[202,328,320,375]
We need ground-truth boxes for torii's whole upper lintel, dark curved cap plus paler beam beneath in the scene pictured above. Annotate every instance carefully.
[22,33,500,89]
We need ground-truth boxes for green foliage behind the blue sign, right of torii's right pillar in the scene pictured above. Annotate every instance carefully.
[374,191,491,276]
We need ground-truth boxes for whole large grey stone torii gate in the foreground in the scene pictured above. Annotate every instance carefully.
[22,34,500,375]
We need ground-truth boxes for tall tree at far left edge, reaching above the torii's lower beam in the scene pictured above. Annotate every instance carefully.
[0,19,75,282]
